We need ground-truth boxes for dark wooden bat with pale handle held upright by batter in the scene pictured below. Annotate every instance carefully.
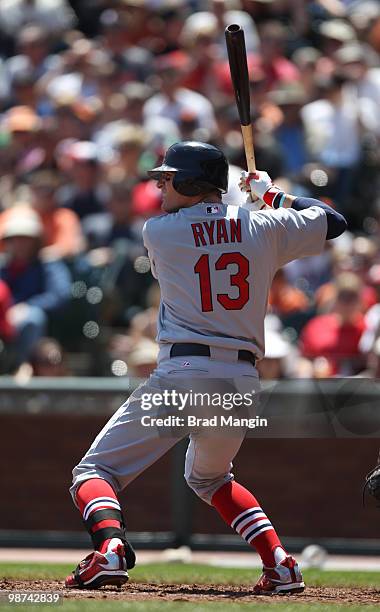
[225,24,256,172]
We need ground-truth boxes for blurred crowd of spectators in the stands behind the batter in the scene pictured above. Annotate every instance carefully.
[0,0,380,379]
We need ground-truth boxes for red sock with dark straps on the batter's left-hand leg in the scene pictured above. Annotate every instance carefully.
[75,478,123,552]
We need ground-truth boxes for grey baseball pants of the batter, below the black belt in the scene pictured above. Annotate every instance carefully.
[70,347,259,504]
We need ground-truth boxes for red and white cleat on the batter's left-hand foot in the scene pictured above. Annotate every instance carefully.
[65,544,128,589]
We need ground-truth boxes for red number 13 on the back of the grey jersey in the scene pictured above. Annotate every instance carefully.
[194,253,249,312]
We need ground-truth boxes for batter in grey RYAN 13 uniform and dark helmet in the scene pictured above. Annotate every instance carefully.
[66,142,346,594]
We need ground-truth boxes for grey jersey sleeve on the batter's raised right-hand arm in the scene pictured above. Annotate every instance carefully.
[253,206,327,268]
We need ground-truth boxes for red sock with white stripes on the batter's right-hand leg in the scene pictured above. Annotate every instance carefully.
[211,480,286,567]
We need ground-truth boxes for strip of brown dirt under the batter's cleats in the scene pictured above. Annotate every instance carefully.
[0,580,380,605]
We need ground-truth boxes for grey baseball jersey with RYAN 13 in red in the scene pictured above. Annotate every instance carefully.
[143,202,327,358]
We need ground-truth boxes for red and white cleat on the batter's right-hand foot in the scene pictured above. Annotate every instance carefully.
[253,556,305,595]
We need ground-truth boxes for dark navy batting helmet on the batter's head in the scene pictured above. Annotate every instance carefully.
[148,141,228,196]
